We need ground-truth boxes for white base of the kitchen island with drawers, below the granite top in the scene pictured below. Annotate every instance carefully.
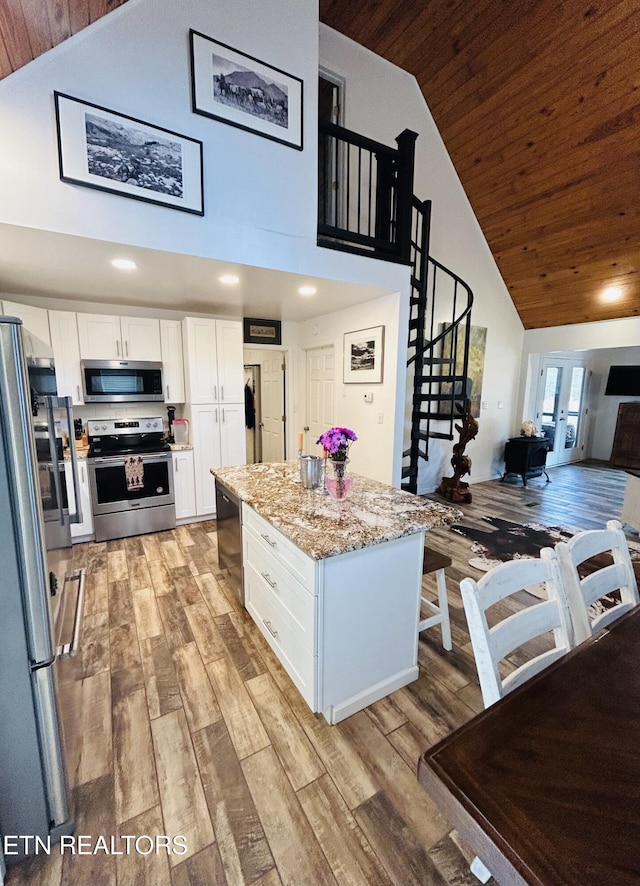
[242,504,424,724]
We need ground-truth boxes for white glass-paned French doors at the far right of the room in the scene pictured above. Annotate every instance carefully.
[536,357,587,466]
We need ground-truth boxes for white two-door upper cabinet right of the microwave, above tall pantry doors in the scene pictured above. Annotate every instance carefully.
[184,317,244,403]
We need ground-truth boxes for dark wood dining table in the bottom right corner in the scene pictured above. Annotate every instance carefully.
[418,609,640,886]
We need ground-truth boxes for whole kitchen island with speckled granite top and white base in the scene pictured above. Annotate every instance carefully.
[211,462,462,723]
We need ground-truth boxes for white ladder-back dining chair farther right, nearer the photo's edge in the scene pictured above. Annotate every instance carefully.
[552,520,640,643]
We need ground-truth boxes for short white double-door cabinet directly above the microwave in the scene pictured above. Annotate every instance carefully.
[78,314,162,361]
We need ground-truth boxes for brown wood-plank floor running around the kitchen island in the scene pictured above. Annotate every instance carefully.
[7,463,626,886]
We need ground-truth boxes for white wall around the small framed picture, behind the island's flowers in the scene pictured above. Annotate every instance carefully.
[294,294,407,486]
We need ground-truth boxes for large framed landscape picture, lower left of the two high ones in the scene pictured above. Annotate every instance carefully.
[54,92,204,215]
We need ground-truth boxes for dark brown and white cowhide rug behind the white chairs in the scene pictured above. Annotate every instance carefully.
[451,517,640,605]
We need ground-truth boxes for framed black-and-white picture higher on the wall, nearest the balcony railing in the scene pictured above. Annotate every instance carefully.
[189,30,302,151]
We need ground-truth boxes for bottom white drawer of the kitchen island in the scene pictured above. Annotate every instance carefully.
[245,564,317,711]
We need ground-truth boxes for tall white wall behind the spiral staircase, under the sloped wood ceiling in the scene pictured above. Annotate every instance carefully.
[320,25,524,492]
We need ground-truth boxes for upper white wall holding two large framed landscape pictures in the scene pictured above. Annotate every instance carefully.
[0,0,410,298]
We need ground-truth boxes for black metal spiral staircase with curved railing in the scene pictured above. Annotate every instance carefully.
[402,197,473,493]
